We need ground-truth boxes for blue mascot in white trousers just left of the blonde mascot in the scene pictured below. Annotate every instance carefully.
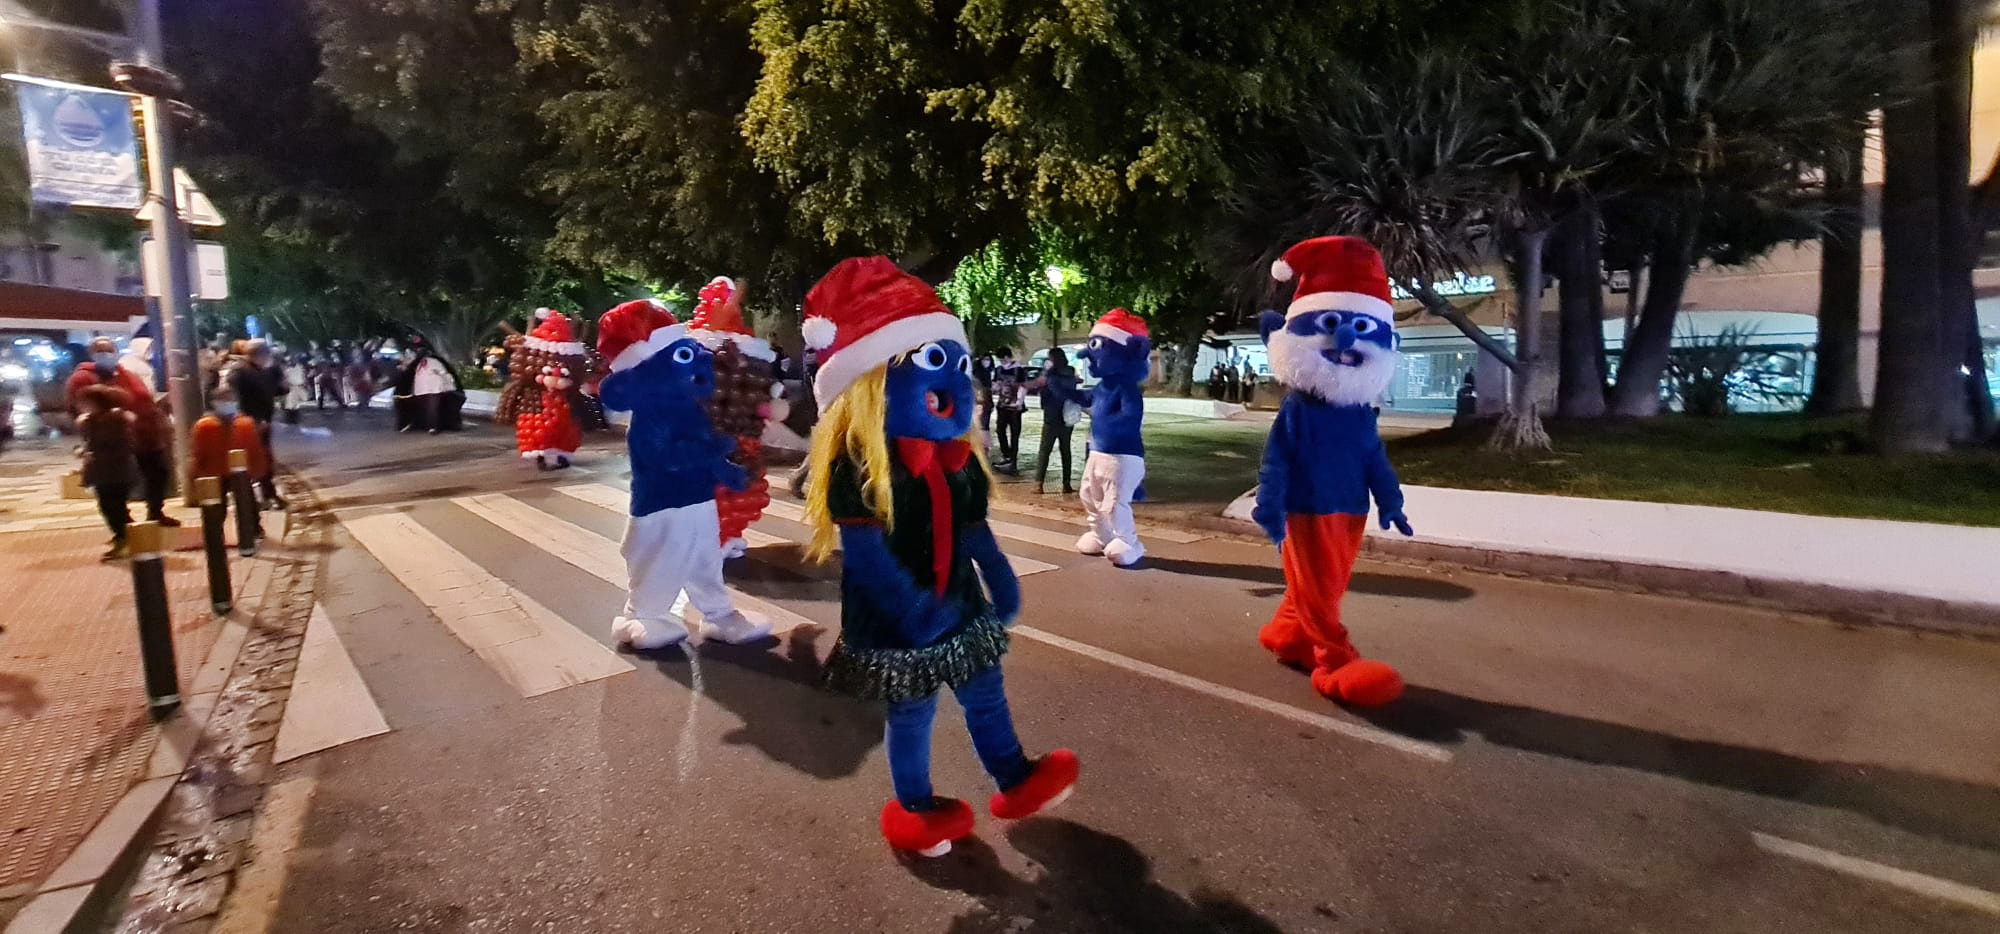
[598,302,770,650]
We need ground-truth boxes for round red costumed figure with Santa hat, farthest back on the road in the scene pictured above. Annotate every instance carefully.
[494,308,596,470]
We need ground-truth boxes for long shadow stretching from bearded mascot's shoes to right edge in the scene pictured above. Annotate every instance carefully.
[1362,686,2000,850]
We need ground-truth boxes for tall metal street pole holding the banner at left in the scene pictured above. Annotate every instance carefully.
[132,0,202,506]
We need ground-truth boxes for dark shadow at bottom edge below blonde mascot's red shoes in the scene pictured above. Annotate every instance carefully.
[908,818,1280,934]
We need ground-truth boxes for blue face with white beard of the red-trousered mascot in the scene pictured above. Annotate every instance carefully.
[1258,312,1398,406]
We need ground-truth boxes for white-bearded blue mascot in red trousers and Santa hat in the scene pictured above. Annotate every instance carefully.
[1254,236,1412,706]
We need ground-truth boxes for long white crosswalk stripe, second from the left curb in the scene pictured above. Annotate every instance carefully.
[344,512,632,698]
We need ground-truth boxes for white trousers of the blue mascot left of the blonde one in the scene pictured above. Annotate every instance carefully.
[618,500,736,626]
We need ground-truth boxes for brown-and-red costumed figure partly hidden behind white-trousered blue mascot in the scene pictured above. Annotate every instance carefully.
[688,276,782,558]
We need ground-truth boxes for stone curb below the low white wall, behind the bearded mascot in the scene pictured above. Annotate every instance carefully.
[1188,516,2000,640]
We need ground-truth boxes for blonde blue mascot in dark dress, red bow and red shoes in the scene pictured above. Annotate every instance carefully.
[804,256,1078,856]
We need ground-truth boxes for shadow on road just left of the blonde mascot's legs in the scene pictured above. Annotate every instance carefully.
[638,626,882,778]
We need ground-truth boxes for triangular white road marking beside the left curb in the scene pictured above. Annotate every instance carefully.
[272,604,388,762]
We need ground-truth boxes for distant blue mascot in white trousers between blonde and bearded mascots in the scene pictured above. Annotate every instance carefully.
[1076,308,1152,568]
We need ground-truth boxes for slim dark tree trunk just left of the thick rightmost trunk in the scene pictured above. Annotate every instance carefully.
[1806,132,1866,416]
